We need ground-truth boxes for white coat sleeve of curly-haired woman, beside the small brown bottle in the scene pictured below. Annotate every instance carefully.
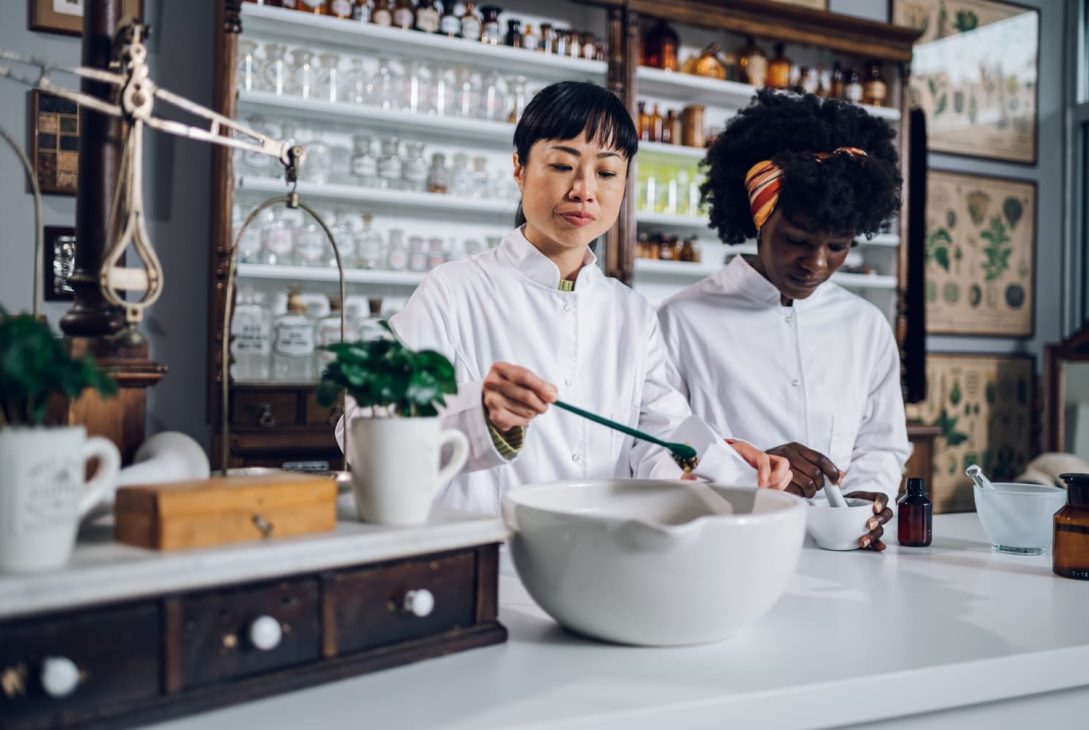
[840,329,911,504]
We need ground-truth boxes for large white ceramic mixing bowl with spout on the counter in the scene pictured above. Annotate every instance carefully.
[503,479,808,646]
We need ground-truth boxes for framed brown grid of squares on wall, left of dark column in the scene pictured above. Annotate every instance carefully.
[30,89,79,195]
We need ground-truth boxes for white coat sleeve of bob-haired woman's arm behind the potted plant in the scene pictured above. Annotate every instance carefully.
[337,272,516,472]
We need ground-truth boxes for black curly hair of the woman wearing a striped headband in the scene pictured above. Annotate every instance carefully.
[700,89,903,243]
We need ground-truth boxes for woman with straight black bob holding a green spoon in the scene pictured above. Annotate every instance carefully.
[338,82,790,514]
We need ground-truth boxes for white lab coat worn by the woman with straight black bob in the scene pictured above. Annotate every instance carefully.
[338,230,756,513]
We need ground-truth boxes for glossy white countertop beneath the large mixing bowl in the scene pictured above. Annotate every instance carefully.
[144,513,1089,730]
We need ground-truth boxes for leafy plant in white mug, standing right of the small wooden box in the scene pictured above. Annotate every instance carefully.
[317,323,468,525]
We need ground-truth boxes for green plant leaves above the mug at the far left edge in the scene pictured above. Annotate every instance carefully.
[0,307,118,426]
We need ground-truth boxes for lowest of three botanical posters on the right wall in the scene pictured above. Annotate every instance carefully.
[907,354,1035,512]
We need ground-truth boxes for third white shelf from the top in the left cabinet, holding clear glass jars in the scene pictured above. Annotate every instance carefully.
[238,176,517,220]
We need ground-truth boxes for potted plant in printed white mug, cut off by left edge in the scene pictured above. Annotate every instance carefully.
[0,307,121,571]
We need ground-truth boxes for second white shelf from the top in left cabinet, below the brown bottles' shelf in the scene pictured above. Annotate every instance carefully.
[238,90,514,148]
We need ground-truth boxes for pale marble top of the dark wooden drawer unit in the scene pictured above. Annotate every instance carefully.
[0,512,510,620]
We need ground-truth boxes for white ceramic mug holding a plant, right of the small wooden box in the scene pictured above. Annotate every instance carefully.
[347,417,469,525]
